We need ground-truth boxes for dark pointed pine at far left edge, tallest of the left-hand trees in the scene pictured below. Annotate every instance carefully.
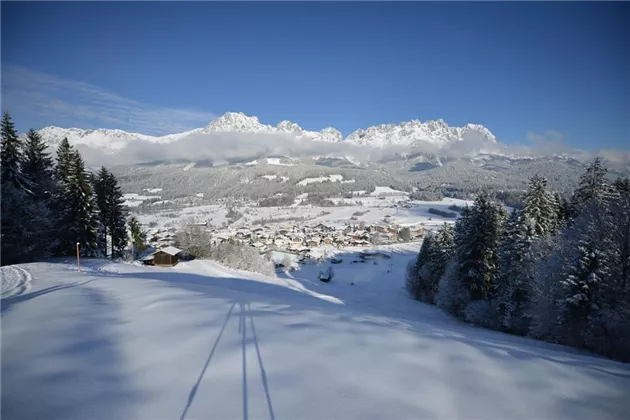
[0,112,28,191]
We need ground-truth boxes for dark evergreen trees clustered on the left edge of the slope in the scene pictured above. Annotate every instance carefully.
[0,112,141,265]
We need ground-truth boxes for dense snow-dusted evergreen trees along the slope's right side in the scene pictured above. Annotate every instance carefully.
[406,159,630,361]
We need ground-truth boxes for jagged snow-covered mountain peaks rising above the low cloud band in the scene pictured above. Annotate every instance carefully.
[39,112,497,154]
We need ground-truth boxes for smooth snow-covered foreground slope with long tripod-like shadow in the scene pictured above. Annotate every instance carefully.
[0,256,630,420]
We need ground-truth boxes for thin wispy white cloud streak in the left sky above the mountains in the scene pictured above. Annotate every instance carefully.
[3,65,216,135]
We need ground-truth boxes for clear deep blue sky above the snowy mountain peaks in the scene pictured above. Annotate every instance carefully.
[0,0,630,150]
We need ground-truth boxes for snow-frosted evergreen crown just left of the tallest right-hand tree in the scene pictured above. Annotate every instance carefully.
[524,175,558,236]
